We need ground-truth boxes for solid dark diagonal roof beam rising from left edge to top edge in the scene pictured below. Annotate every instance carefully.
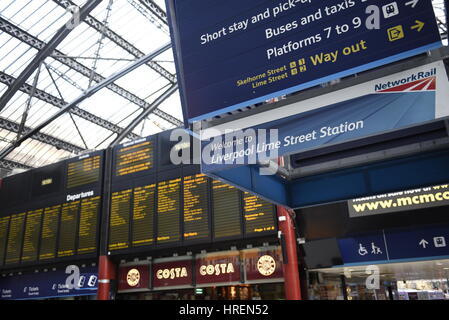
[0,0,101,111]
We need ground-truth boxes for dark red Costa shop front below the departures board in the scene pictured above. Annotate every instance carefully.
[117,247,284,300]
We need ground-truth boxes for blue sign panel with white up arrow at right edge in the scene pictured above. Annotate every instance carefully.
[385,226,449,259]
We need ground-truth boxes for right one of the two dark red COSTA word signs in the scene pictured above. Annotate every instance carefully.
[195,251,241,285]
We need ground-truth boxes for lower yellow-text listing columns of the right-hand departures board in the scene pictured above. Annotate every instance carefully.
[108,165,277,255]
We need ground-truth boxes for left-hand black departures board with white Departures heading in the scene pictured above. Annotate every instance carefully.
[0,151,104,268]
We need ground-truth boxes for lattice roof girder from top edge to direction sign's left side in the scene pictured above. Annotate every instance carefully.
[53,0,176,83]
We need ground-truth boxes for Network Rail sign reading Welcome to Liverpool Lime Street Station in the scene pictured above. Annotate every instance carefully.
[201,61,449,173]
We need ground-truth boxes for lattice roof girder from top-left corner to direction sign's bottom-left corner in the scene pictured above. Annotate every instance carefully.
[0,17,183,127]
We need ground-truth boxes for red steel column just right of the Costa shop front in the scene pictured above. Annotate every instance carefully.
[277,206,302,300]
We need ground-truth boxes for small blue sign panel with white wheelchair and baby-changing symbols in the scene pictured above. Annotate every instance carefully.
[338,233,388,263]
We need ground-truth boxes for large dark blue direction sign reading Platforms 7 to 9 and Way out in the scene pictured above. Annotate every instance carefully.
[166,0,441,122]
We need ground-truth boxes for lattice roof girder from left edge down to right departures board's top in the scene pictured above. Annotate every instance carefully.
[0,71,140,140]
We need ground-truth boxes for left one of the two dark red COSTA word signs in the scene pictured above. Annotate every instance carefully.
[153,258,193,289]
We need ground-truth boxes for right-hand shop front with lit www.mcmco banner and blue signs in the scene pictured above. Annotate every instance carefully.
[298,185,449,300]
